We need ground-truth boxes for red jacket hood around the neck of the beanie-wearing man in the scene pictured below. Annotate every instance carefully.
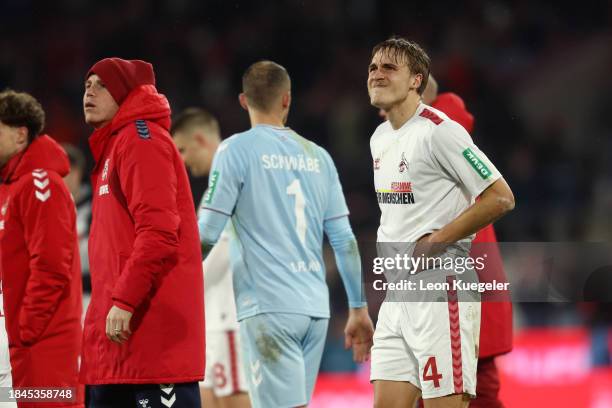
[89,85,171,165]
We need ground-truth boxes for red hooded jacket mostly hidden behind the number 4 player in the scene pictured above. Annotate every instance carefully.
[431,92,512,358]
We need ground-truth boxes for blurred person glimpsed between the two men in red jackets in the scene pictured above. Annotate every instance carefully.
[62,144,91,293]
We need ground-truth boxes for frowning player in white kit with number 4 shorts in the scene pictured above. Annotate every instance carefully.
[367,38,514,408]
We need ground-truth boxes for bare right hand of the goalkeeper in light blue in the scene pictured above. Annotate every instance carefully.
[344,306,374,363]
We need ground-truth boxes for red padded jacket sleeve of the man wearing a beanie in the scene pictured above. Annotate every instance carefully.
[112,132,180,312]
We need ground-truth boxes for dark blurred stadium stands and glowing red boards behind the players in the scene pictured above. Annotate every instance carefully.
[0,0,612,408]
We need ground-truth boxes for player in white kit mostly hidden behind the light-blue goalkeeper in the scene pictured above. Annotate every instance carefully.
[171,108,250,408]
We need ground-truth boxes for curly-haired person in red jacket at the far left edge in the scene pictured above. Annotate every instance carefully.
[0,87,83,408]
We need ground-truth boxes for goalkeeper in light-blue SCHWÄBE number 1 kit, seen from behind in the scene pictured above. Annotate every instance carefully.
[199,61,373,408]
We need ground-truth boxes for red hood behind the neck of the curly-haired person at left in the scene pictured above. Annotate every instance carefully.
[0,135,70,182]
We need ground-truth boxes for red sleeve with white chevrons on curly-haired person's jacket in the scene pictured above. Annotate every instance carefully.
[19,172,76,345]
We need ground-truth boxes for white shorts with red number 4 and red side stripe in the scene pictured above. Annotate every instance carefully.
[370,271,480,399]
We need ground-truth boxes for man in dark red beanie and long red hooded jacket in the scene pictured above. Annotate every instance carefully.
[81,58,204,408]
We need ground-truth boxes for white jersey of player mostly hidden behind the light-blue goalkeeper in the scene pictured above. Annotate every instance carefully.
[203,228,239,332]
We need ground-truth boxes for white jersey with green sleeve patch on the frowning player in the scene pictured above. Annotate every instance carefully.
[370,103,501,242]
